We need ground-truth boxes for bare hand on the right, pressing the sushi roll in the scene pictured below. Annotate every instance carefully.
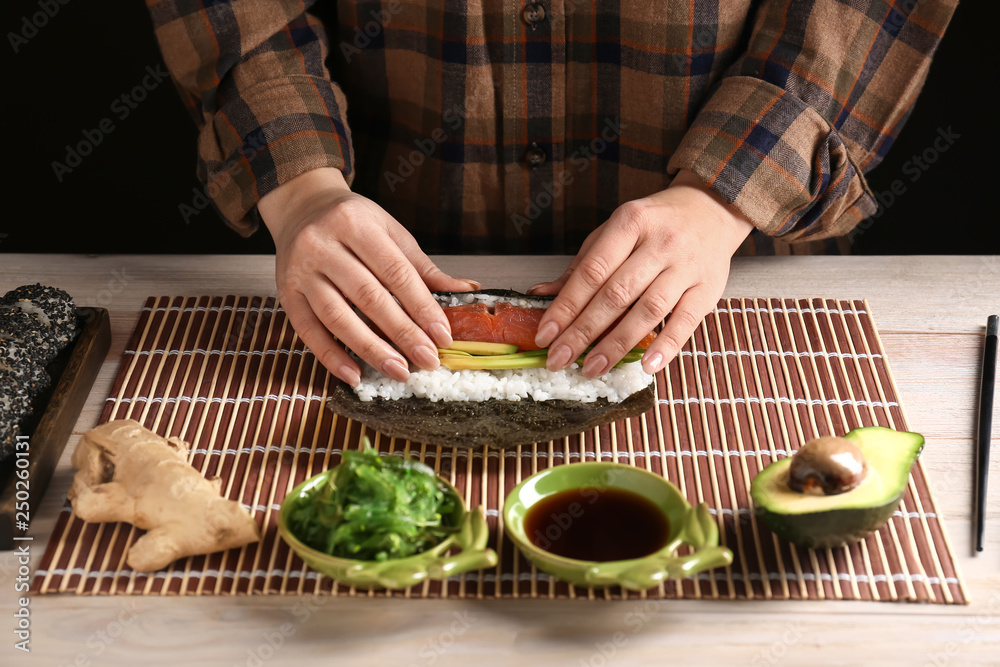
[529,171,753,378]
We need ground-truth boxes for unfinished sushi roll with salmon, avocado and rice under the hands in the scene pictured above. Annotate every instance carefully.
[327,290,655,449]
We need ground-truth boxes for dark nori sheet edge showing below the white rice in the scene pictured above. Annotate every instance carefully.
[327,380,655,450]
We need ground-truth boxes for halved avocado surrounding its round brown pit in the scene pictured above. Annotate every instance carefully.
[750,426,924,549]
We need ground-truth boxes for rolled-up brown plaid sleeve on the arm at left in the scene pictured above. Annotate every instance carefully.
[147,0,353,236]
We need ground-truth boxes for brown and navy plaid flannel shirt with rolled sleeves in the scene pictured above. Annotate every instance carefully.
[147,0,957,253]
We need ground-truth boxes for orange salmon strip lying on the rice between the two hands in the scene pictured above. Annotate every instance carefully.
[444,301,656,351]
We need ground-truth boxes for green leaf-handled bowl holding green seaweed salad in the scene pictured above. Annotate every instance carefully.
[278,466,497,588]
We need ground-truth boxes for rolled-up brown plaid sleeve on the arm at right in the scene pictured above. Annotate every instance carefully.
[668,0,957,241]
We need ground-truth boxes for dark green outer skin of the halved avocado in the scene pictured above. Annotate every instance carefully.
[757,493,903,549]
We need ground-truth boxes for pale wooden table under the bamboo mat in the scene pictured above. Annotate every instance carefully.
[0,255,1000,667]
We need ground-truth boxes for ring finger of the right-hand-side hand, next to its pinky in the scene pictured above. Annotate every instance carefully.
[583,270,688,377]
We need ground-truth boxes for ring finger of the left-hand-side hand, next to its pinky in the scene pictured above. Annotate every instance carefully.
[305,276,416,382]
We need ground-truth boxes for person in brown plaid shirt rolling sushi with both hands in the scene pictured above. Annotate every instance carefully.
[150,0,956,385]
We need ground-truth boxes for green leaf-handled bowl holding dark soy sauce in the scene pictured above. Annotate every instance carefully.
[503,461,733,590]
